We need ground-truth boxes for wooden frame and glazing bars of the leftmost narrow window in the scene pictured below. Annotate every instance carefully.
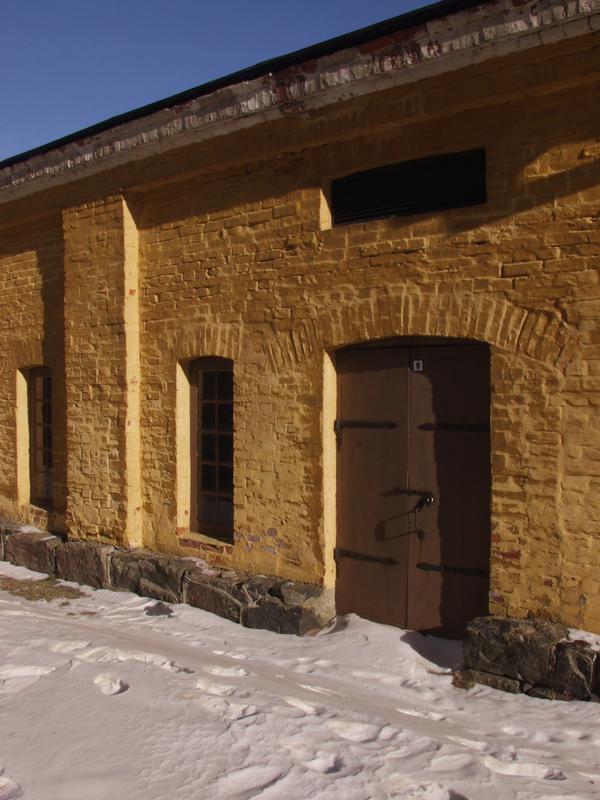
[27,367,54,509]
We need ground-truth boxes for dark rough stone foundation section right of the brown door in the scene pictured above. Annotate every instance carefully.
[454,617,600,702]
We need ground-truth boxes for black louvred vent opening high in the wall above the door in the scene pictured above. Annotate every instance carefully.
[331,149,486,225]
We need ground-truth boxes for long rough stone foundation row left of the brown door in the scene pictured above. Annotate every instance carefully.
[0,521,335,636]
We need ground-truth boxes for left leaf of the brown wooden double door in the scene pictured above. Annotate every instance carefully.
[336,349,408,626]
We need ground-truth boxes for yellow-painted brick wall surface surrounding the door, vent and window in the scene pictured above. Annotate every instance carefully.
[0,31,600,632]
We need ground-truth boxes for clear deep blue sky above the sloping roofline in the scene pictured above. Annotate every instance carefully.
[0,0,428,160]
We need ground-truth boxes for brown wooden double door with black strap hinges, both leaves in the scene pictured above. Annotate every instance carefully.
[335,340,491,636]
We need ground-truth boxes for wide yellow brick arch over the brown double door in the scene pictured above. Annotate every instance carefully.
[264,285,578,371]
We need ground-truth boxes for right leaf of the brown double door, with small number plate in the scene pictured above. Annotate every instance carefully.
[408,345,490,635]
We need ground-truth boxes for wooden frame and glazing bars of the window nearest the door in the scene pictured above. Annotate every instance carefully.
[187,356,235,544]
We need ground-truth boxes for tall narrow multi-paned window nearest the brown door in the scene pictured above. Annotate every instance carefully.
[190,358,233,541]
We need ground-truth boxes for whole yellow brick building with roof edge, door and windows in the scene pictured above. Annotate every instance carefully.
[0,0,600,632]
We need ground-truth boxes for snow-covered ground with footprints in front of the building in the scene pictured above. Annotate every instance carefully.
[0,562,600,800]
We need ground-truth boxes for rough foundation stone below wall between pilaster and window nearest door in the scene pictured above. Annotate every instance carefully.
[110,550,190,603]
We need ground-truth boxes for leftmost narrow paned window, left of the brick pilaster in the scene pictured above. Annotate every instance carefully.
[27,367,52,508]
